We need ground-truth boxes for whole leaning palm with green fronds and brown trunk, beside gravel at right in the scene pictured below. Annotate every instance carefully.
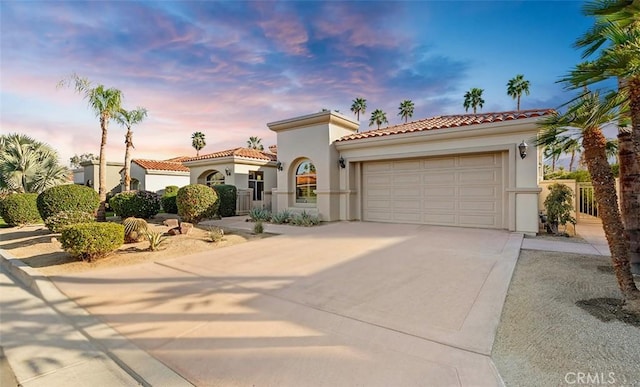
[538,93,640,311]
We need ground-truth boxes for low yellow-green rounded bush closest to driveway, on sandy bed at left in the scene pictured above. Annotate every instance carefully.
[60,222,124,262]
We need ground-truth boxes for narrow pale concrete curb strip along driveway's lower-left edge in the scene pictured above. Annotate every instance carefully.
[0,249,193,387]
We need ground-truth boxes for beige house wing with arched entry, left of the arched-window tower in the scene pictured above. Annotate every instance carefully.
[182,148,277,207]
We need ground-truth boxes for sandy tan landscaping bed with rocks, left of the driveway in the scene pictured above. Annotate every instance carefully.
[0,217,269,276]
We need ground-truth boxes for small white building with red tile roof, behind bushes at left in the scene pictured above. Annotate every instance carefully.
[120,157,189,194]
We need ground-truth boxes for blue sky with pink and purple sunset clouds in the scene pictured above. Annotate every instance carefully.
[0,0,593,168]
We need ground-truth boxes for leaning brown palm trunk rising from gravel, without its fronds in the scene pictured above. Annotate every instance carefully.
[582,128,640,312]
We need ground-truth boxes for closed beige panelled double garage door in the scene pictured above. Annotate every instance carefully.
[362,153,504,228]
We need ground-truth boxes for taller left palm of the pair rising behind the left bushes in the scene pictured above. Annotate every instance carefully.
[58,73,122,221]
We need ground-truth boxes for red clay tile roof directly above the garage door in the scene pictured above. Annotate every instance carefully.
[337,109,554,141]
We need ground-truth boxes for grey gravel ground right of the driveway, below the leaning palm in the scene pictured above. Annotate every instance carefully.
[492,250,640,387]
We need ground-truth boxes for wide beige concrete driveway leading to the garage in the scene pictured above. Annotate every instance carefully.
[48,222,522,386]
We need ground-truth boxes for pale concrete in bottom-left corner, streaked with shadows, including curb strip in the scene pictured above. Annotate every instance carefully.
[0,250,191,387]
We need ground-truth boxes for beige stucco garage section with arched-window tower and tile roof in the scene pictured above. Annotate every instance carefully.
[268,110,553,233]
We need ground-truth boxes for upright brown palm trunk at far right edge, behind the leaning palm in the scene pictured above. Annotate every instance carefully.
[618,77,640,274]
